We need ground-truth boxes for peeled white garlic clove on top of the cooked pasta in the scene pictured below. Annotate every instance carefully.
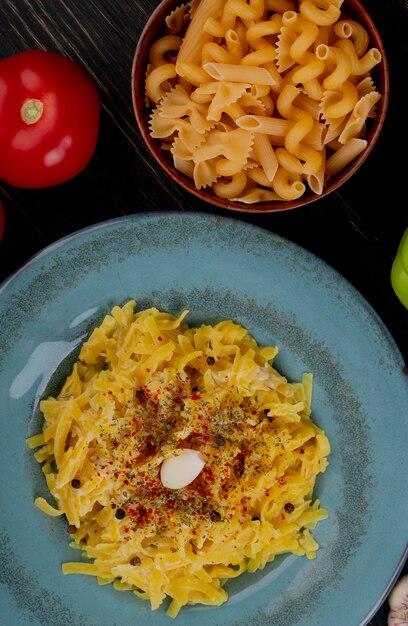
[160,448,205,489]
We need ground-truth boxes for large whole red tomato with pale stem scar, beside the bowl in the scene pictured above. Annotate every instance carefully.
[0,50,100,188]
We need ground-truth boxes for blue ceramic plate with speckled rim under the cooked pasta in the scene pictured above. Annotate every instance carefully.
[0,213,408,626]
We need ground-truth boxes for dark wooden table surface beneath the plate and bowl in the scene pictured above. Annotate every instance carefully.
[0,0,408,626]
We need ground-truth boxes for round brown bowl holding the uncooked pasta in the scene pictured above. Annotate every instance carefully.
[131,0,389,213]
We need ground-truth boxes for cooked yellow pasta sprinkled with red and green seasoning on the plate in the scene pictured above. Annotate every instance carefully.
[28,301,330,617]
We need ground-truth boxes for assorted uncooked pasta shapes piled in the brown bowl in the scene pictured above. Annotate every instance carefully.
[145,0,382,204]
